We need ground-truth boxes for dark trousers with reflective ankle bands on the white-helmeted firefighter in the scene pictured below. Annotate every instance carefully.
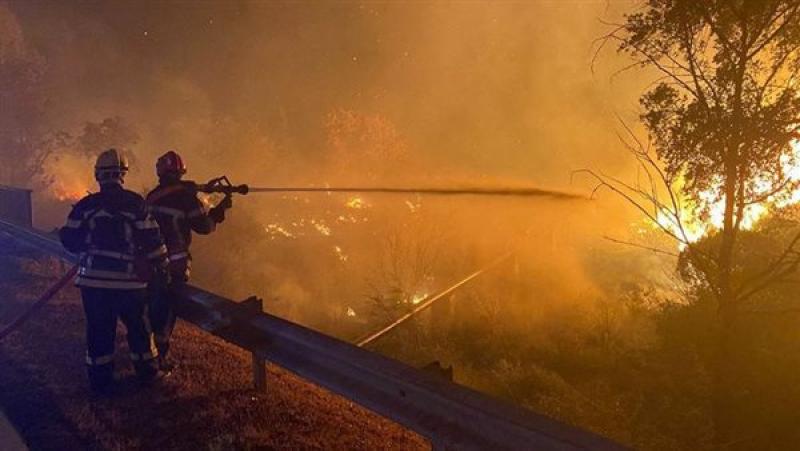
[81,287,158,390]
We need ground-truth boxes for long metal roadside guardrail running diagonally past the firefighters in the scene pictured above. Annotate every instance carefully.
[0,221,623,450]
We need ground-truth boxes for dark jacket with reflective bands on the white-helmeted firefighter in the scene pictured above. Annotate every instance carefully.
[60,184,167,290]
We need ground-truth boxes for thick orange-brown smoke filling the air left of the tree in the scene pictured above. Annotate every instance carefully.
[0,1,664,338]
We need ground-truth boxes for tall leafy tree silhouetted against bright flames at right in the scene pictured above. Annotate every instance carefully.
[590,0,800,445]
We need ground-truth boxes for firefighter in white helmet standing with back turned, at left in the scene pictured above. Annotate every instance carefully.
[60,149,167,394]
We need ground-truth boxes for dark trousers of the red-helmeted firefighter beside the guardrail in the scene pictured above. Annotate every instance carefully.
[149,259,189,359]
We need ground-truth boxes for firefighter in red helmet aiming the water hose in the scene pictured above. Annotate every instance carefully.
[147,150,232,371]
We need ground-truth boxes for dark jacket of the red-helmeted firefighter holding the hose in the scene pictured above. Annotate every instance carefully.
[147,181,217,262]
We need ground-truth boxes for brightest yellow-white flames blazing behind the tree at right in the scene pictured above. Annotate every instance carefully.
[657,141,800,248]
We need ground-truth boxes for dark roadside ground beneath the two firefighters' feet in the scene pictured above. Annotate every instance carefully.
[0,235,429,450]
